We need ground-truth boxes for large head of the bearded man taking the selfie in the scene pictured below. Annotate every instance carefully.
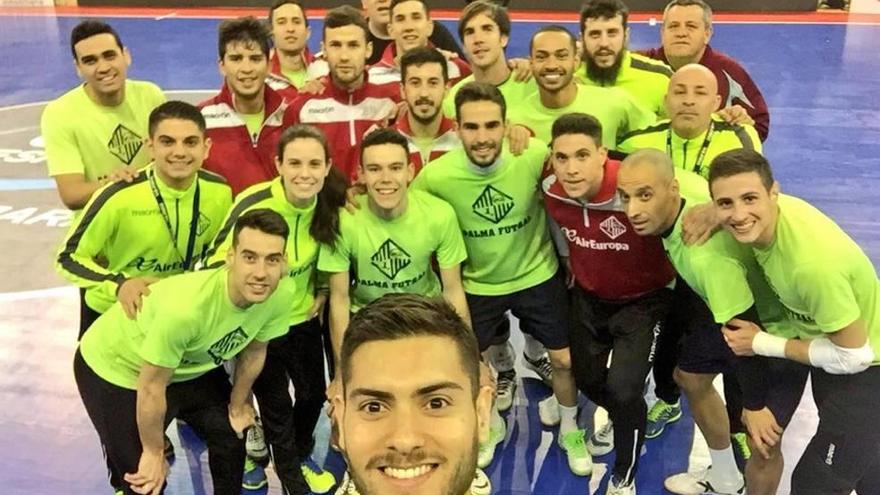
[333,294,492,495]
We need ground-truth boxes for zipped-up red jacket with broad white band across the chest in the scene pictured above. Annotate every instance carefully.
[284,74,400,180]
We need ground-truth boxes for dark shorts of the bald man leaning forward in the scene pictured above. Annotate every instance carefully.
[667,278,734,375]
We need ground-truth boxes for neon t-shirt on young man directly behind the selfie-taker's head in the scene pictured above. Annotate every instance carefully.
[318,191,467,312]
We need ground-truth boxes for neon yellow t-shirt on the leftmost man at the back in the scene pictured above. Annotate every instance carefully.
[40,80,165,182]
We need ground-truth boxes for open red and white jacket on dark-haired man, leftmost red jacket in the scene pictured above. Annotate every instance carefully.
[199,84,287,194]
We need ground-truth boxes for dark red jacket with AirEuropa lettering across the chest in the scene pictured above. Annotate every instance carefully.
[541,160,675,301]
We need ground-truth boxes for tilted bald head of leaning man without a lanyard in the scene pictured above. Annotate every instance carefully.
[617,149,681,235]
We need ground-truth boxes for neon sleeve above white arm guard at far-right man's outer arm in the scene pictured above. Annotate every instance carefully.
[792,263,862,333]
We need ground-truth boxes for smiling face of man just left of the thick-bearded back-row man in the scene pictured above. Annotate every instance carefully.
[531,31,577,93]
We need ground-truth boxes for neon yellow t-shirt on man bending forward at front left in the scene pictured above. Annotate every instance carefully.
[80,268,294,390]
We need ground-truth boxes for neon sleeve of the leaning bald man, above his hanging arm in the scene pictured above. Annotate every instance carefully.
[691,254,755,324]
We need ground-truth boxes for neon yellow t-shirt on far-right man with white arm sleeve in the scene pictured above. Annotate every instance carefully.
[754,195,880,365]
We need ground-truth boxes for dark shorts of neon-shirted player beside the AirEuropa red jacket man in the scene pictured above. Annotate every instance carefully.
[466,271,568,352]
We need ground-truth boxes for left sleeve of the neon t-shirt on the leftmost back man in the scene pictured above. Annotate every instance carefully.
[40,102,86,177]
